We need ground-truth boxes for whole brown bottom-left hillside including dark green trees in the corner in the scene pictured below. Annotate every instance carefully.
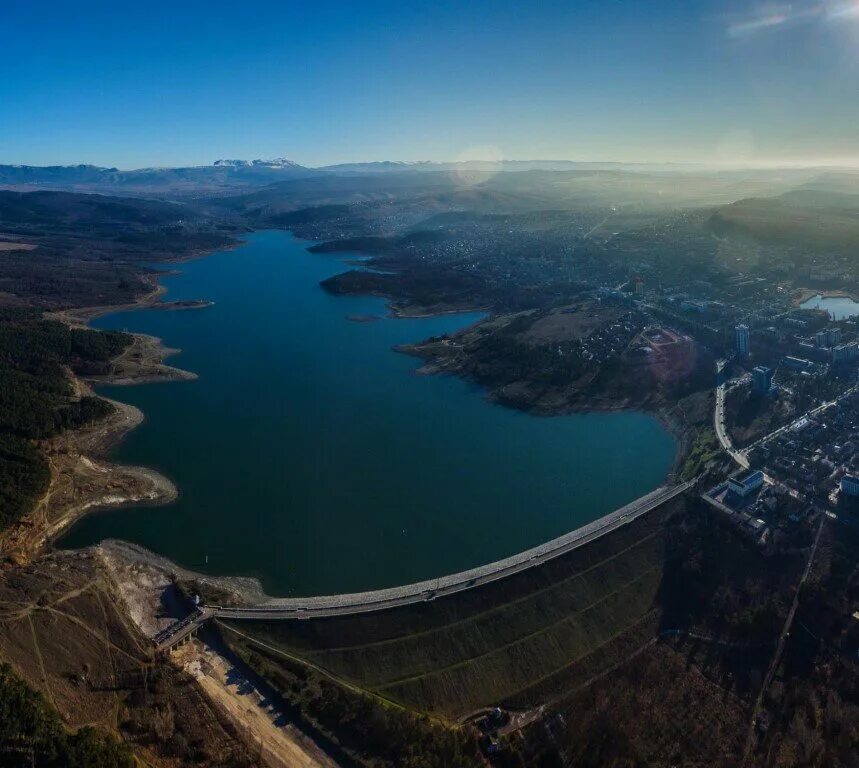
[0,552,254,768]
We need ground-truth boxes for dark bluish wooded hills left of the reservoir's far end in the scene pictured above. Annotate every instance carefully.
[0,190,236,308]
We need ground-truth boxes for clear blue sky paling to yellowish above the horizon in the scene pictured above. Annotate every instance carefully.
[0,0,859,168]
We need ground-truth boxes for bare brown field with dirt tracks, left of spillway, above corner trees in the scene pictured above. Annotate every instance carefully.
[0,552,255,766]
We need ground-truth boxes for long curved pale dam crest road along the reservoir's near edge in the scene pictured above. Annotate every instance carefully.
[153,478,697,650]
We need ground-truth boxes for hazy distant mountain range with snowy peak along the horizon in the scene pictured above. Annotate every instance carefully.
[0,158,859,204]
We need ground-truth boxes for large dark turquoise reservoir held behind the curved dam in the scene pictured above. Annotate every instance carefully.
[61,232,675,595]
